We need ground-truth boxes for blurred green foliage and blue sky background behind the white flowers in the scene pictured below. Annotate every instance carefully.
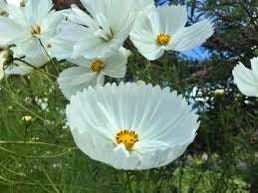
[0,0,258,193]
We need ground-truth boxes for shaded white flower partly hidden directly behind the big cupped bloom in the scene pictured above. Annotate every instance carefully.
[57,49,128,99]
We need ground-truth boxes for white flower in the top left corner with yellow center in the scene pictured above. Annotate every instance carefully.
[0,0,64,57]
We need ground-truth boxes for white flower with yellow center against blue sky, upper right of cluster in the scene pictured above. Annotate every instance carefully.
[130,5,214,60]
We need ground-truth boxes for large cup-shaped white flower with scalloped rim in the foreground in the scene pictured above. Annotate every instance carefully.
[66,83,199,170]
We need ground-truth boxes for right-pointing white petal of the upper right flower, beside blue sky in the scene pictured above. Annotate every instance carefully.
[170,20,214,51]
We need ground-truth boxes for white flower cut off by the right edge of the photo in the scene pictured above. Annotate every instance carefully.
[233,57,258,97]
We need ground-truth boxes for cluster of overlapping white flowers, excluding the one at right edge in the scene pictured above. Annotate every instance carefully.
[0,0,214,169]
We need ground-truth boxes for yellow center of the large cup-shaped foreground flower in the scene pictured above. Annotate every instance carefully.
[116,130,139,151]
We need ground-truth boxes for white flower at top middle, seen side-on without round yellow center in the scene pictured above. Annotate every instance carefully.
[55,0,136,58]
